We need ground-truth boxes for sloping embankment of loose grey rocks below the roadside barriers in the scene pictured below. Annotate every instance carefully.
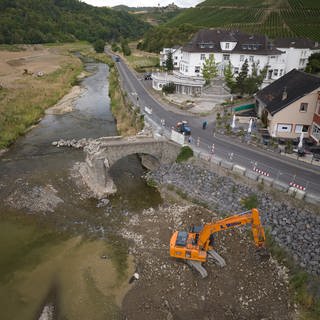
[147,163,320,275]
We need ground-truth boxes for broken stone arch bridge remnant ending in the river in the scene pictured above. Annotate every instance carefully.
[80,136,181,198]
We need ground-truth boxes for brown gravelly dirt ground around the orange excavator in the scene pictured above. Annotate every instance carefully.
[121,204,295,320]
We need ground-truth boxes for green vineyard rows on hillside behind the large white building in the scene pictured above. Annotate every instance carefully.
[167,0,320,41]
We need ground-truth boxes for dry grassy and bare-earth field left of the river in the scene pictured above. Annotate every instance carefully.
[0,43,90,149]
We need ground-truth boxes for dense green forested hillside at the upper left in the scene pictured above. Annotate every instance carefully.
[0,0,149,44]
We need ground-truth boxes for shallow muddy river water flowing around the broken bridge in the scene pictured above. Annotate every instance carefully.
[0,62,161,319]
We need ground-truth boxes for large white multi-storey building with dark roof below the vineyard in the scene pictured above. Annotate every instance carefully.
[153,29,320,93]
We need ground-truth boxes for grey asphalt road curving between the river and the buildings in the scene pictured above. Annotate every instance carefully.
[111,55,320,194]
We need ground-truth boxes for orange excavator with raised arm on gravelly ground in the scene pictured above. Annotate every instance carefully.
[170,209,265,277]
